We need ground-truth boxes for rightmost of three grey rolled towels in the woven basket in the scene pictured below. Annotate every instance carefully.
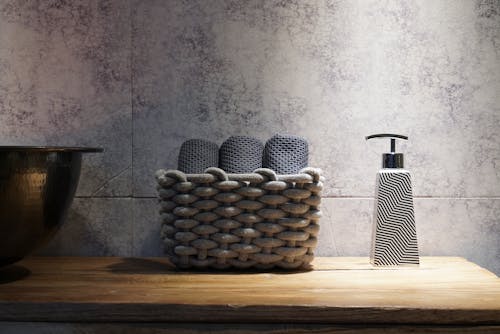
[262,134,309,174]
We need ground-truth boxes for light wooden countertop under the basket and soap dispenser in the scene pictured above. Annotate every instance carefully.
[0,257,500,333]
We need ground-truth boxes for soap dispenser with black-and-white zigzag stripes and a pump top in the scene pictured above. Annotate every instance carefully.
[366,133,419,266]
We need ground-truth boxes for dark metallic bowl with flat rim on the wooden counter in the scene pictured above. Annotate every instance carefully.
[0,146,102,266]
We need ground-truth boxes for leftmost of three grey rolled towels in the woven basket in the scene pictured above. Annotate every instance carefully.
[177,139,219,174]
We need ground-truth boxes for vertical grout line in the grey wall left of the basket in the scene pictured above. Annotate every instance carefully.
[129,0,136,256]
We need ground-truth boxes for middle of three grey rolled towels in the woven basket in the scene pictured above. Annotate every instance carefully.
[219,136,264,173]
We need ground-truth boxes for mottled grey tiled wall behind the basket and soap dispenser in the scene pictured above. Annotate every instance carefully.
[0,0,500,274]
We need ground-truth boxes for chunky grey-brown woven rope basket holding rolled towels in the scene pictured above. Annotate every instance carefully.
[156,167,323,270]
